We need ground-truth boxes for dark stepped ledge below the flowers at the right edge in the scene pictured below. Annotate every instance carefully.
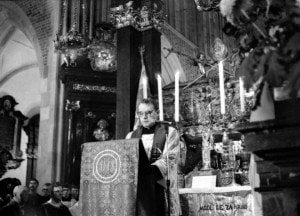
[239,99,300,216]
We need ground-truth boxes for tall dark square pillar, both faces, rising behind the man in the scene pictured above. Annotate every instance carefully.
[116,26,161,139]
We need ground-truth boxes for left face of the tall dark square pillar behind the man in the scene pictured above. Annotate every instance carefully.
[116,26,141,139]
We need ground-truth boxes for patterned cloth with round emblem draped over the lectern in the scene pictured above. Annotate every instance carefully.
[78,139,139,216]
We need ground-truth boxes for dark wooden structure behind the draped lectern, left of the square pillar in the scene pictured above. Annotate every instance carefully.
[60,58,117,185]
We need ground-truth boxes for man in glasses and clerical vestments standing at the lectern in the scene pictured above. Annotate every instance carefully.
[126,99,180,216]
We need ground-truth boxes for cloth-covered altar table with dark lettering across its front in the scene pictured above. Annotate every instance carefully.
[179,186,254,216]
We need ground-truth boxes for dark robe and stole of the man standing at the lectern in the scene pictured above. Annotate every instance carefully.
[131,125,167,216]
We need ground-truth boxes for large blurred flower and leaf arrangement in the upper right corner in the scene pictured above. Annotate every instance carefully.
[219,0,300,105]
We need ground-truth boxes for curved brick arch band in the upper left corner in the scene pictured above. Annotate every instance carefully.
[0,1,44,77]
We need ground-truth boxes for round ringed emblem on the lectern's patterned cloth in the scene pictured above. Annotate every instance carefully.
[93,150,121,183]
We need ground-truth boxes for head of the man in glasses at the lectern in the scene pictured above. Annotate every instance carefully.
[137,98,157,128]
